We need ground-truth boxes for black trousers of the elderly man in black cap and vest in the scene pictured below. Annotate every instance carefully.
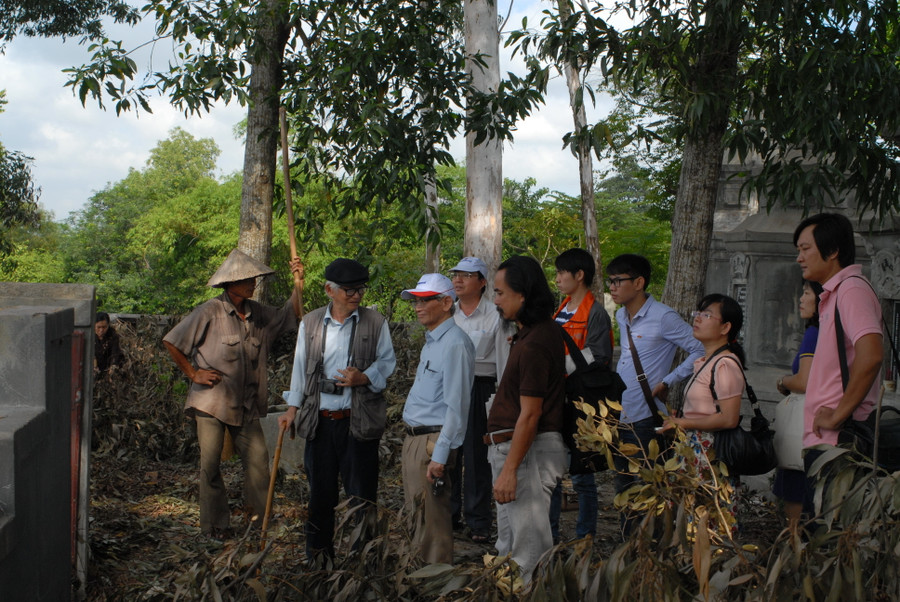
[303,417,379,558]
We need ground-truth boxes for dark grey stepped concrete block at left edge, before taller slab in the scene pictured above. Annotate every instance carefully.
[0,307,74,602]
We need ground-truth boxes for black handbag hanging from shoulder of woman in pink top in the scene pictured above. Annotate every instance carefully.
[709,357,778,476]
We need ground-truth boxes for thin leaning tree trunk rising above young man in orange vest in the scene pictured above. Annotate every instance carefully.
[558,0,603,302]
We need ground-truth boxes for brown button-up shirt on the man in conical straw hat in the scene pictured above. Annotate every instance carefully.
[163,292,297,426]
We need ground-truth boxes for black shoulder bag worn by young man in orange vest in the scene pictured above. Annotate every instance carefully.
[560,327,626,474]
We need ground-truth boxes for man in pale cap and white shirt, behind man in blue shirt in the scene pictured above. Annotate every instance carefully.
[450,257,513,543]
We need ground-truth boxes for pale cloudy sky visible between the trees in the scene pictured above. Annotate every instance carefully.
[0,2,609,219]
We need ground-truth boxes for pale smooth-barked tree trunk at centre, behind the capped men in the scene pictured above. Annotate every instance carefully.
[463,0,503,273]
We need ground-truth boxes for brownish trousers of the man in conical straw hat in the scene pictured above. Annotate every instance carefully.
[196,413,269,533]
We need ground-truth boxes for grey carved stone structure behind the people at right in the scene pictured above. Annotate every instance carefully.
[706,157,900,401]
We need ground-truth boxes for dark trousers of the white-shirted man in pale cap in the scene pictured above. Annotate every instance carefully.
[450,376,494,535]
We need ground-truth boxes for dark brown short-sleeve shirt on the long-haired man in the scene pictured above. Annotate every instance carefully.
[487,319,566,433]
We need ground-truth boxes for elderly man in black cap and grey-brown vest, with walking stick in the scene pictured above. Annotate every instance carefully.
[279,258,397,565]
